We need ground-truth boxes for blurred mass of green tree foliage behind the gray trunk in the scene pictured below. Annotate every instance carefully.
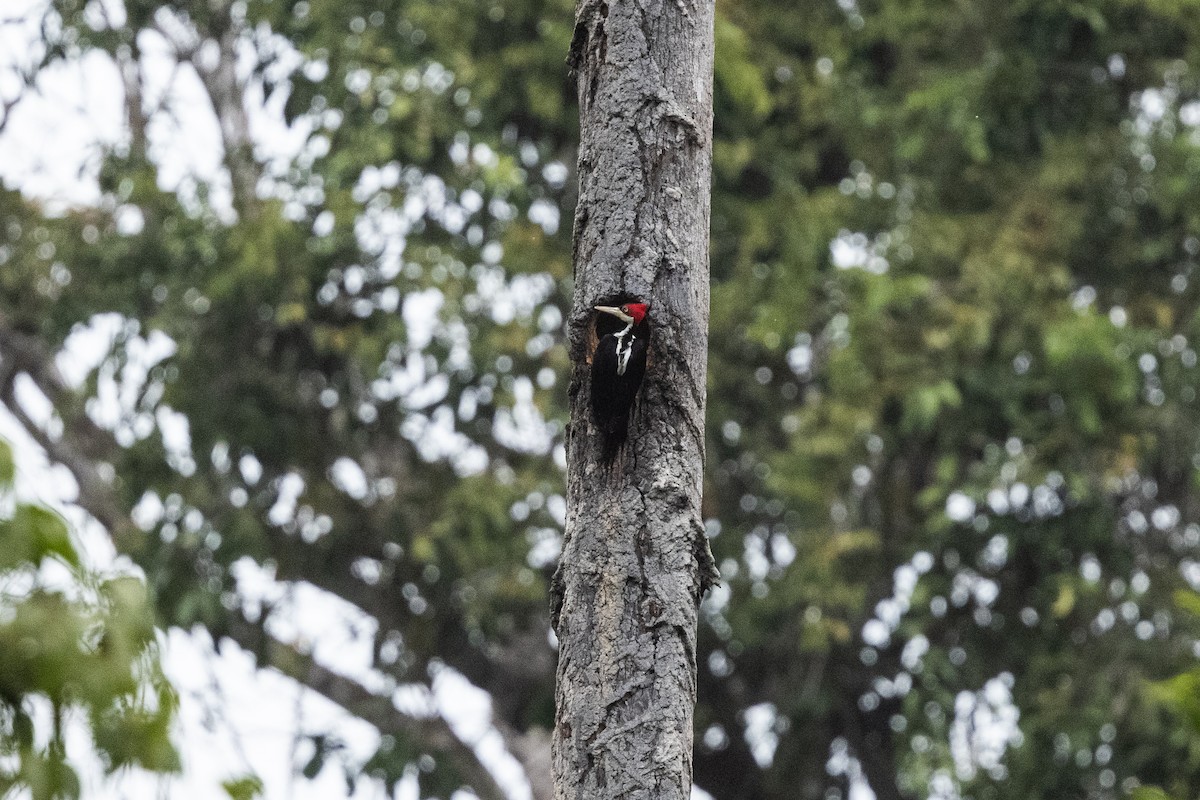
[7,0,1200,800]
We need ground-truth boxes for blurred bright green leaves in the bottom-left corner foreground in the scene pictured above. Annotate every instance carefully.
[0,441,180,800]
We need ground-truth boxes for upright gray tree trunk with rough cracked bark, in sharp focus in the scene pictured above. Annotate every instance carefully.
[552,0,715,800]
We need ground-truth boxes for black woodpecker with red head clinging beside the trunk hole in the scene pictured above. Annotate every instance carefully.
[592,302,650,461]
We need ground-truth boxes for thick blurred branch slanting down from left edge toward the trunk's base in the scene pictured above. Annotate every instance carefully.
[0,312,506,800]
